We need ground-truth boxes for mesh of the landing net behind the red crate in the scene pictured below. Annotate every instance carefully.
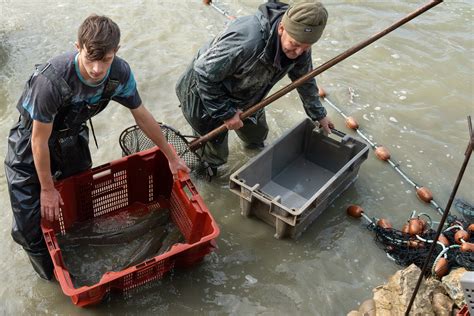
[119,123,213,178]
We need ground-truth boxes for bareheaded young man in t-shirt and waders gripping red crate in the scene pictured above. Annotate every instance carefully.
[5,15,189,279]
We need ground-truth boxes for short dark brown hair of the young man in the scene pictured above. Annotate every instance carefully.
[77,14,120,60]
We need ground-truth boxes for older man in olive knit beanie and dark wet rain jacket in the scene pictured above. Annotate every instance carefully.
[176,1,334,169]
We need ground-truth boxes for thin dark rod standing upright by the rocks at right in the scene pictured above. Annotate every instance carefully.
[405,116,474,316]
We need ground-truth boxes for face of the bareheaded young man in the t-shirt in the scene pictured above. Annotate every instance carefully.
[76,43,117,83]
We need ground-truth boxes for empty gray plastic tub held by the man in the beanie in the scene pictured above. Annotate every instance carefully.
[230,119,369,238]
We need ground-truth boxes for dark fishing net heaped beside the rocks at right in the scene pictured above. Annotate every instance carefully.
[367,216,474,274]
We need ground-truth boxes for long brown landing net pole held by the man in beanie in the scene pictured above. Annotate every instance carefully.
[189,0,443,151]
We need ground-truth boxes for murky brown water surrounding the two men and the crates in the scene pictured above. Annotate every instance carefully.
[0,0,474,315]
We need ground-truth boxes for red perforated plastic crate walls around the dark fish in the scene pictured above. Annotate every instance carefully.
[41,147,219,306]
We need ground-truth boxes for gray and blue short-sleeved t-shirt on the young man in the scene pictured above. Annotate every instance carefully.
[17,52,142,123]
